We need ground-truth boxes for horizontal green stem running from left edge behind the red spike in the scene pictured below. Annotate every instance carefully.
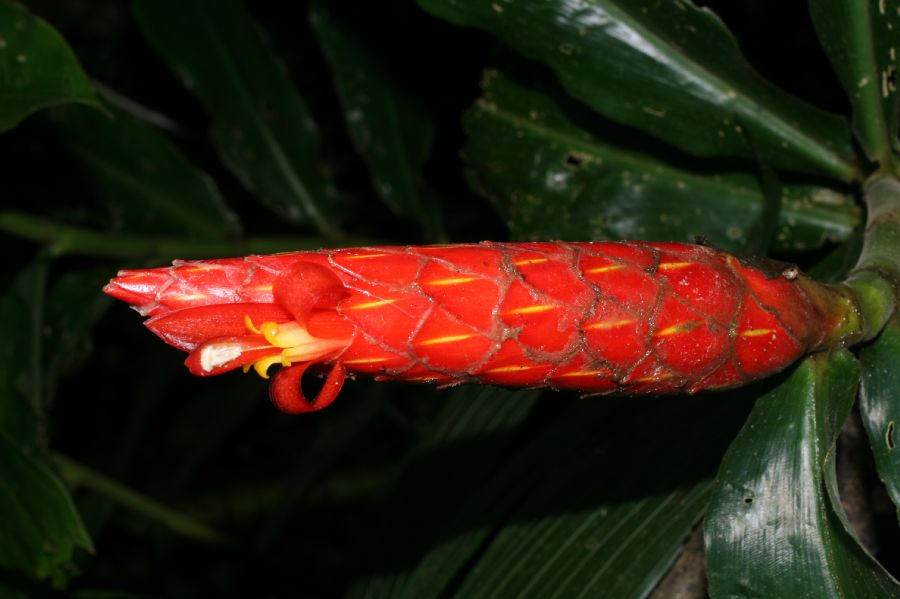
[0,211,380,259]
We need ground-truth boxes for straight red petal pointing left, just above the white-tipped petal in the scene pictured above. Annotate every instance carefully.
[144,304,291,351]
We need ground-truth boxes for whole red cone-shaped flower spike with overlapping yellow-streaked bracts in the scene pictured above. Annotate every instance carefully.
[105,242,841,412]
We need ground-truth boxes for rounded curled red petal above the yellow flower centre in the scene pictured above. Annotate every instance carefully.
[272,262,347,325]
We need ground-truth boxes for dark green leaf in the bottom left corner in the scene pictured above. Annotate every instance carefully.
[0,431,93,584]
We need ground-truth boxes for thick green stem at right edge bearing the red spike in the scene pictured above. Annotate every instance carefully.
[845,175,900,341]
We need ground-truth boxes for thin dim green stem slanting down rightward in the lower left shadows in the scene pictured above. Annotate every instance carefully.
[50,453,228,543]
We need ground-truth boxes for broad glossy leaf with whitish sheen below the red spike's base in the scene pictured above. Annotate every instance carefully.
[705,350,900,598]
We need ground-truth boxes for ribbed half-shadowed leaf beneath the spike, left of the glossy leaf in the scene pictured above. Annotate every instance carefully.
[352,396,747,598]
